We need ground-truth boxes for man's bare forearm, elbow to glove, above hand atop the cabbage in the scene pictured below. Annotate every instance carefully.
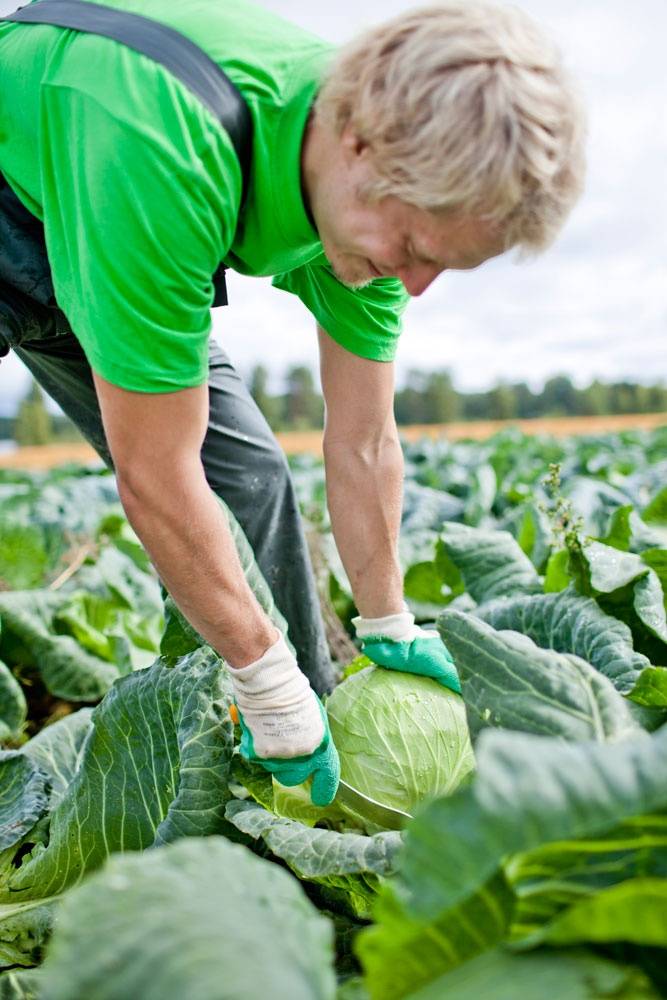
[324,434,403,618]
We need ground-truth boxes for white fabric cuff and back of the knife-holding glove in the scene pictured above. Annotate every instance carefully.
[229,635,324,757]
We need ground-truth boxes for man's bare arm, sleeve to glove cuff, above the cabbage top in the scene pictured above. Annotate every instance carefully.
[317,326,403,618]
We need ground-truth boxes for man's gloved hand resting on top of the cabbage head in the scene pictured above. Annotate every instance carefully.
[352,611,461,694]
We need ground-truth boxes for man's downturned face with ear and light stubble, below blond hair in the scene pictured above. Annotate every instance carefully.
[313,127,505,295]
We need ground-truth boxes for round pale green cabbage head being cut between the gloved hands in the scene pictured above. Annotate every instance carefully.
[326,666,475,812]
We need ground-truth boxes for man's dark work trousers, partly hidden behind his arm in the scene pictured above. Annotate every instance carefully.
[0,174,333,693]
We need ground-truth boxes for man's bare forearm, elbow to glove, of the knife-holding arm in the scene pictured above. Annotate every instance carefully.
[118,462,278,667]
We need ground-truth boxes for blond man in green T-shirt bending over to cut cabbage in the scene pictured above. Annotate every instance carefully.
[0,0,582,804]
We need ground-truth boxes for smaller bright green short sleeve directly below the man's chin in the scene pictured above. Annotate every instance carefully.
[273,256,410,361]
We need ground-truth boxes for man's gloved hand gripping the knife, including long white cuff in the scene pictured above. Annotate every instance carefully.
[230,636,340,806]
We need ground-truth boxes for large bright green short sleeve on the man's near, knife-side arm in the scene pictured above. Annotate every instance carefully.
[36,71,241,392]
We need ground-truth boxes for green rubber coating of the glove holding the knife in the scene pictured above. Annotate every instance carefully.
[236,695,340,806]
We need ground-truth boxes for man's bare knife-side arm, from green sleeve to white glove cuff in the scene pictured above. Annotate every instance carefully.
[95,375,278,667]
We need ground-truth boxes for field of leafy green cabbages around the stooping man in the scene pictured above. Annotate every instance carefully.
[0,428,667,1000]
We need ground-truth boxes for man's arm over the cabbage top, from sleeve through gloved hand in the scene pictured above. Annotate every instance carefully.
[318,327,461,693]
